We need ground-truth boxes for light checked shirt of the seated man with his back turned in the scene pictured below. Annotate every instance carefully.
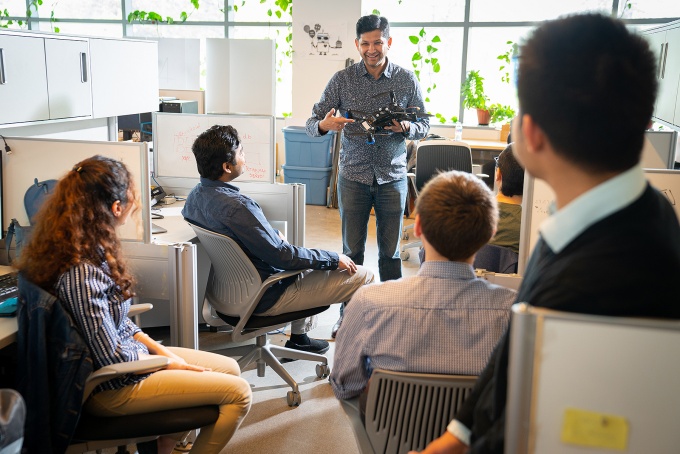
[330,261,516,399]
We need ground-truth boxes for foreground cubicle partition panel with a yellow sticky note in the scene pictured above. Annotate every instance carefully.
[504,303,680,454]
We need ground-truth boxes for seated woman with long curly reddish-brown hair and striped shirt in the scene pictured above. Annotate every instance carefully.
[15,156,251,453]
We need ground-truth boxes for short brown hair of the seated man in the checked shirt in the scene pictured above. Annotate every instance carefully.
[416,170,498,261]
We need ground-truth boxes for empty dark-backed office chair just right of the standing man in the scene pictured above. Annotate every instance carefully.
[399,139,472,260]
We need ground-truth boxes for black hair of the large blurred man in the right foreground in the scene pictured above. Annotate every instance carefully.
[515,14,657,172]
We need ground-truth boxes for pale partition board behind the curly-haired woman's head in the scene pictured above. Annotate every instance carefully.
[2,137,151,243]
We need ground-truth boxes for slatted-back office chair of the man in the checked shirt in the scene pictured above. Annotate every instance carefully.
[340,369,477,454]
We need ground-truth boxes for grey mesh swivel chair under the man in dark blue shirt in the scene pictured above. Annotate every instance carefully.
[189,223,330,407]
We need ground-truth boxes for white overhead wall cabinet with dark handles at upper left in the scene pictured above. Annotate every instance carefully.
[0,30,158,126]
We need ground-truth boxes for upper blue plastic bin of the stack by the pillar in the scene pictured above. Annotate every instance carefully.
[282,126,335,168]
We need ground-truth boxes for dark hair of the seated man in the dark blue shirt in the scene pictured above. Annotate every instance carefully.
[191,125,241,180]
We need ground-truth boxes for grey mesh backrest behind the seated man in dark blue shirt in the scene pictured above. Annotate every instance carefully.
[191,224,262,317]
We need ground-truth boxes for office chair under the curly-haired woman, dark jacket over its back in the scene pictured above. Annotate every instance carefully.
[17,274,219,454]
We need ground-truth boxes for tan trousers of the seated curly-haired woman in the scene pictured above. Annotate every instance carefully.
[85,347,251,453]
